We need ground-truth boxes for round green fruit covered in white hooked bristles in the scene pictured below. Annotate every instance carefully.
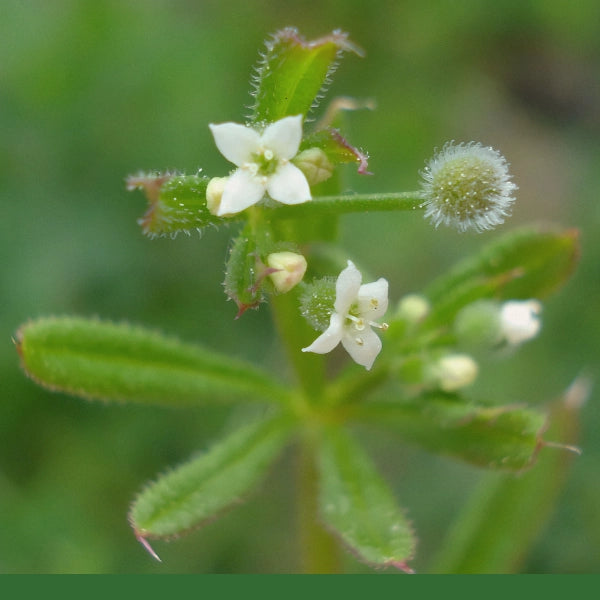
[421,142,517,232]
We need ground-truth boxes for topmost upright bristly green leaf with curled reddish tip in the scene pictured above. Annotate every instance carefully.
[252,28,362,122]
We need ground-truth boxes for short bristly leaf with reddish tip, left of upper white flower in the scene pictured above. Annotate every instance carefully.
[127,173,223,237]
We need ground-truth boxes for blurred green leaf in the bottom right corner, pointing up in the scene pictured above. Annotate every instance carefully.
[429,382,587,573]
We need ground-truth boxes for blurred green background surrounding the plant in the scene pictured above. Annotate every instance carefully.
[0,0,600,573]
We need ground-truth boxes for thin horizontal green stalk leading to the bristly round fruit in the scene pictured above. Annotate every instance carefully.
[270,192,423,219]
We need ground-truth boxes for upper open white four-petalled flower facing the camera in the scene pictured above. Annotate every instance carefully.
[209,115,311,216]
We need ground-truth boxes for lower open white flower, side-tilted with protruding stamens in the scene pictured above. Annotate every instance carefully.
[302,261,388,370]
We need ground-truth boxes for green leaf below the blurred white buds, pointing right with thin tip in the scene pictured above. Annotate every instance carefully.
[355,393,546,471]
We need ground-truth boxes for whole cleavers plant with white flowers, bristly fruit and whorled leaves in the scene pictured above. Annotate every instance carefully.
[16,29,578,572]
